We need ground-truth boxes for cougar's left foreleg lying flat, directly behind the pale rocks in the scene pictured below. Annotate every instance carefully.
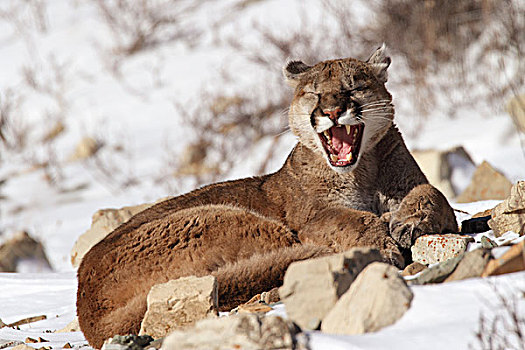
[299,207,404,267]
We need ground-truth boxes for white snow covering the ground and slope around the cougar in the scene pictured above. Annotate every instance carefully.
[0,0,525,349]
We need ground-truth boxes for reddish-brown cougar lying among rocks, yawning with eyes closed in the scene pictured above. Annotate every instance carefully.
[77,45,457,348]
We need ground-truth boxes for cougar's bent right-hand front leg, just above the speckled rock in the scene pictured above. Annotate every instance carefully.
[386,184,458,249]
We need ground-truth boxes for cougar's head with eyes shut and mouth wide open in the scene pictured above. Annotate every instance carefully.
[284,45,394,173]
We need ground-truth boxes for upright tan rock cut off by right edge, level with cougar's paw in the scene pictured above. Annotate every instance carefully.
[488,181,525,237]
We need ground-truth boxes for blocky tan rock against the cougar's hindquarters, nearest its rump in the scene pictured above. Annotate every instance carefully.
[139,276,218,338]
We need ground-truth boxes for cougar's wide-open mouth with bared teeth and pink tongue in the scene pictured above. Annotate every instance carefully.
[318,124,365,167]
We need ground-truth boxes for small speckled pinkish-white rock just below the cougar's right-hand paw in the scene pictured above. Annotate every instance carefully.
[410,234,474,265]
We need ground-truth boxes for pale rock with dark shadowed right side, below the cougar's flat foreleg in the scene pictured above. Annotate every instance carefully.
[279,248,382,329]
